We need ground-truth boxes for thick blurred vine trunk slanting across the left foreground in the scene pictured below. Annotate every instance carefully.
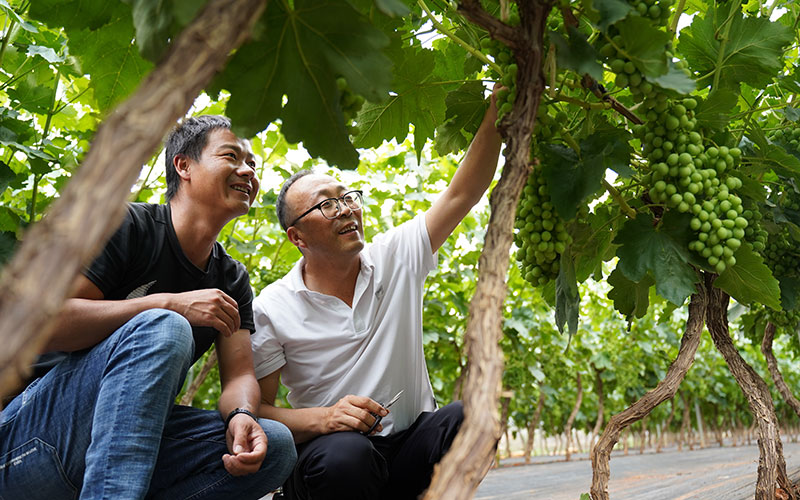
[0,0,267,396]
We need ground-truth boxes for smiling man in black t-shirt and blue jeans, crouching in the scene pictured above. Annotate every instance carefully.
[0,116,296,500]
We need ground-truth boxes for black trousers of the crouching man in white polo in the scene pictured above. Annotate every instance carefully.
[284,401,464,500]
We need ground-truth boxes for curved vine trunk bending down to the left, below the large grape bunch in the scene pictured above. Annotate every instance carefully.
[591,284,708,500]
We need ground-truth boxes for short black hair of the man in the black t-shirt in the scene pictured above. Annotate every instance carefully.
[164,115,231,201]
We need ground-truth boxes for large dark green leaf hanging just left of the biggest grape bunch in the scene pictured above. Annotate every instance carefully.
[614,212,697,305]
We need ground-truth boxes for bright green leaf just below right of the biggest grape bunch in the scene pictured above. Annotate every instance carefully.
[714,245,781,310]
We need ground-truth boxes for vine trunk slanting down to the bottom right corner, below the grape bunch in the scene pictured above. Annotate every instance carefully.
[706,279,797,500]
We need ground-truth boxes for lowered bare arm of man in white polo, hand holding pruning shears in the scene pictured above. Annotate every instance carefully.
[258,370,389,443]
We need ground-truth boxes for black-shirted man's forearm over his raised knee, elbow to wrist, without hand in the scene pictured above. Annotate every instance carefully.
[42,294,169,352]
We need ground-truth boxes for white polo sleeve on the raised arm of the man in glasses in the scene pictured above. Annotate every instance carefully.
[372,213,438,278]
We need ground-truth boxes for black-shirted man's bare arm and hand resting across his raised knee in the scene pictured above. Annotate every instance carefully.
[43,275,240,352]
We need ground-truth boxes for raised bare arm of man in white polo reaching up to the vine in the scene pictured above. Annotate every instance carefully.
[425,88,502,252]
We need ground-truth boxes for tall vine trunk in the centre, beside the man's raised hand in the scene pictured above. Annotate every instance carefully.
[424,0,553,500]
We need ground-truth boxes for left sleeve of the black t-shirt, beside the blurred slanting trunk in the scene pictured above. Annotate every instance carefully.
[83,206,139,297]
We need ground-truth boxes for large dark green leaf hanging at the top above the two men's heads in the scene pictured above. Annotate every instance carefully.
[214,0,391,168]
